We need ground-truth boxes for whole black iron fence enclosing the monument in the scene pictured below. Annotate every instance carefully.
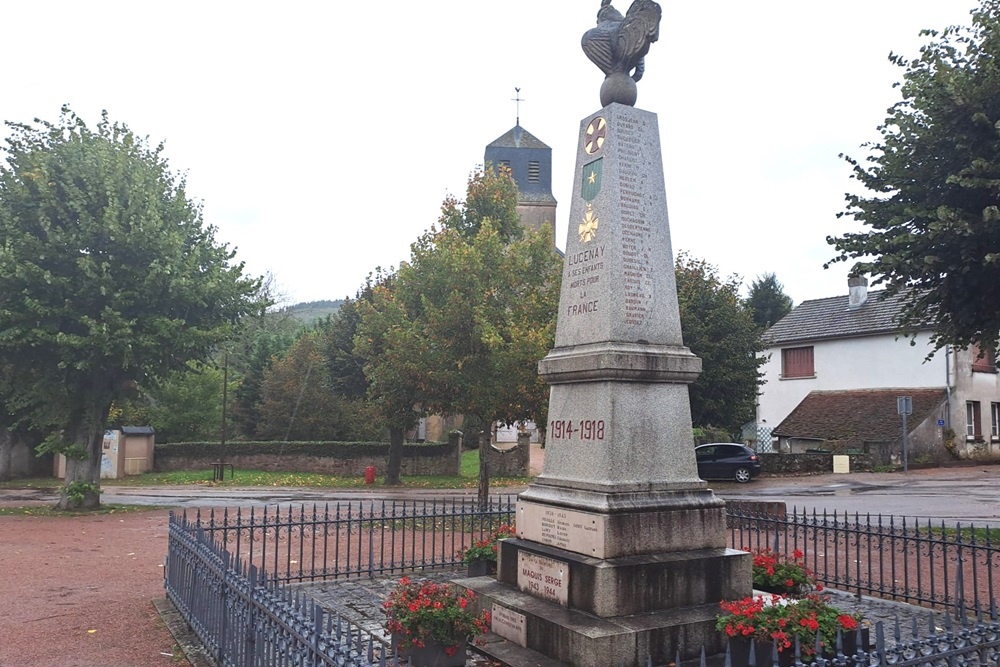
[165,496,1000,667]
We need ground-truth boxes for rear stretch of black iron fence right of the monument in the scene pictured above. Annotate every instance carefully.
[727,503,1000,609]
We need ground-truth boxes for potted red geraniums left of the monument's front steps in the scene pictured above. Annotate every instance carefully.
[383,577,490,667]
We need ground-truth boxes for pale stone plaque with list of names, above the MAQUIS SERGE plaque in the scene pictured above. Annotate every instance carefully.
[517,501,607,558]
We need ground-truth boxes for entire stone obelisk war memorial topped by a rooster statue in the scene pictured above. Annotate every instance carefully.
[461,0,751,667]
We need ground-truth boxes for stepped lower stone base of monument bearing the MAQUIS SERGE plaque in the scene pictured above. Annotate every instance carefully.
[456,538,752,667]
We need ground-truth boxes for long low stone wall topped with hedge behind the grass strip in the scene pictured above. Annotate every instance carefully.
[153,442,461,477]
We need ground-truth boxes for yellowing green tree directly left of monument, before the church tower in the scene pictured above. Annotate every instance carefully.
[397,168,562,503]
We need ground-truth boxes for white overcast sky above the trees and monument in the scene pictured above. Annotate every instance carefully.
[0,0,978,303]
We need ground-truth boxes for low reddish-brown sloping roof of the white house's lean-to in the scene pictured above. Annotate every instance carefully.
[774,387,946,447]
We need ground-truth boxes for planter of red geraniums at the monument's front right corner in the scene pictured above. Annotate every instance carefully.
[715,593,868,667]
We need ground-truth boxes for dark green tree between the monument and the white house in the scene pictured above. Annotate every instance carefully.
[676,253,764,433]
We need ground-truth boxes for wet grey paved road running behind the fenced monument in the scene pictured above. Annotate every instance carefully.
[7,465,1000,528]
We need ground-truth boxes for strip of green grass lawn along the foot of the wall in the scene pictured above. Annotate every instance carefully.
[0,450,531,489]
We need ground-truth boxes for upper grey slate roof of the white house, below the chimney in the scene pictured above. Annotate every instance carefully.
[764,290,929,345]
